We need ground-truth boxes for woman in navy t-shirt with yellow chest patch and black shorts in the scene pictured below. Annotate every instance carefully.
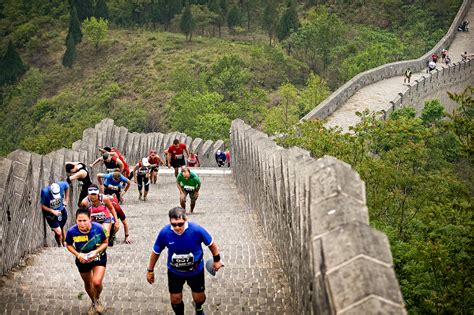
[66,208,107,315]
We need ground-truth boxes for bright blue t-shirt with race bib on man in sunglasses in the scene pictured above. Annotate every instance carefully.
[153,222,212,276]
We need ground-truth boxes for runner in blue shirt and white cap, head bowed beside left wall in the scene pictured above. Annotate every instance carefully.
[41,182,69,247]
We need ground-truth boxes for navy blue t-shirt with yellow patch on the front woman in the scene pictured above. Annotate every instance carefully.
[66,222,107,255]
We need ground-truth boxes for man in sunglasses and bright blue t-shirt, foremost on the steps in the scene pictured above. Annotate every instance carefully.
[146,207,223,315]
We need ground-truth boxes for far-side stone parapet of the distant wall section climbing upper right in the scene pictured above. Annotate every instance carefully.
[301,0,472,121]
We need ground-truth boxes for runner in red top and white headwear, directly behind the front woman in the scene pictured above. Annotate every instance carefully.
[80,184,120,246]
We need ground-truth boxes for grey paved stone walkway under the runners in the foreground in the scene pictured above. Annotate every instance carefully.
[0,170,292,314]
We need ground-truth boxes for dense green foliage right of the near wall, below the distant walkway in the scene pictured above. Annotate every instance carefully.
[281,91,474,314]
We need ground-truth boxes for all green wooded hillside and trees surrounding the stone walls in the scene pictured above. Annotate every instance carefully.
[0,0,474,314]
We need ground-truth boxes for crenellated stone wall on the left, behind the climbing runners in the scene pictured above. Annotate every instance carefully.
[0,119,224,275]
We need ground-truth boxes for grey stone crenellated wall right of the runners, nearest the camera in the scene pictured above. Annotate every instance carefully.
[231,120,406,314]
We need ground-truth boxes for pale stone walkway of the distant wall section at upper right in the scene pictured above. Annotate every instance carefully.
[325,3,474,131]
